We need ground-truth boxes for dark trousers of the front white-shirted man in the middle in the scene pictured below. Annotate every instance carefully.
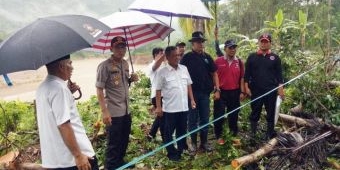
[163,112,187,158]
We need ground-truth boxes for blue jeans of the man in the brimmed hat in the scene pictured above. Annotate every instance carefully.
[188,91,210,145]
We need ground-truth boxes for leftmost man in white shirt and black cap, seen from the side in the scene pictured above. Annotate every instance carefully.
[36,55,99,170]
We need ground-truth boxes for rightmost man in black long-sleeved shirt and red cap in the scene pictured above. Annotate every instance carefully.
[244,34,284,139]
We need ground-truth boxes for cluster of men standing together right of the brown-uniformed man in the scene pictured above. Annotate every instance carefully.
[148,32,284,161]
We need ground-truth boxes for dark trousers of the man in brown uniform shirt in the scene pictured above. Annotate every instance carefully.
[105,114,131,170]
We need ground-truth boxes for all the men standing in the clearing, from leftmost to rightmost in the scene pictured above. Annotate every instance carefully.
[36,29,284,170]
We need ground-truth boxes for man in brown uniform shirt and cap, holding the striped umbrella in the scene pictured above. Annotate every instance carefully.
[96,36,138,170]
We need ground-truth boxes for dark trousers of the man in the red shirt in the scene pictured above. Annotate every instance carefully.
[214,89,240,139]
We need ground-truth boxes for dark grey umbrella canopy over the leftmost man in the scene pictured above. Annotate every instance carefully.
[0,15,110,74]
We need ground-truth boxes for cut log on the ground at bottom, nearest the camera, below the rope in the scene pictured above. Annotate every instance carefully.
[231,138,278,169]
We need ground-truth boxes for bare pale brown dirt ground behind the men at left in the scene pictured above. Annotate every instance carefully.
[0,58,149,102]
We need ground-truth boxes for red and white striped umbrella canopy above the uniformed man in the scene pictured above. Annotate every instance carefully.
[92,11,174,53]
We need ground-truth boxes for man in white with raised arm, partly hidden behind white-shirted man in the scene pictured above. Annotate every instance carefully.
[147,47,165,141]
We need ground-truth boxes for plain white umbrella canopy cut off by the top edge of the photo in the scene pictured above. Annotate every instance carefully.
[128,0,213,19]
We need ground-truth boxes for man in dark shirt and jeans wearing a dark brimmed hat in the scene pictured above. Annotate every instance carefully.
[180,31,220,154]
